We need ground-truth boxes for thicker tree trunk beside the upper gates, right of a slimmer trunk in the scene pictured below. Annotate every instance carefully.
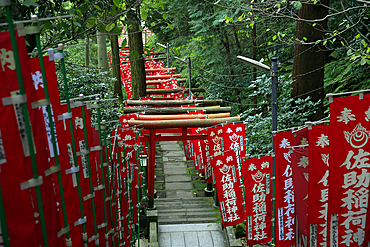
[127,8,146,99]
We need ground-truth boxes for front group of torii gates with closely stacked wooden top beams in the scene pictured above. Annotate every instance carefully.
[124,98,240,210]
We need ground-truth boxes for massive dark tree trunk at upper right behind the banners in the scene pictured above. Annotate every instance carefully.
[292,0,329,120]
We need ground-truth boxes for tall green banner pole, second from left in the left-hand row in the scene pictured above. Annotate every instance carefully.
[31,16,72,246]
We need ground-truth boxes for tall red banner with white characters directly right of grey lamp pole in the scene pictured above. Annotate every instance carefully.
[274,131,296,247]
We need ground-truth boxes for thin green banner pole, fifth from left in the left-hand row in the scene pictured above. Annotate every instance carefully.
[96,112,109,247]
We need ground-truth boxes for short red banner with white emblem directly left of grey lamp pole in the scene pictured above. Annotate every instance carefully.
[242,156,272,245]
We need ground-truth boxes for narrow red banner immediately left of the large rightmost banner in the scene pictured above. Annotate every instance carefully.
[308,125,330,246]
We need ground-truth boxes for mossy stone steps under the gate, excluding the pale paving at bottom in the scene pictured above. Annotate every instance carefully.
[154,142,220,225]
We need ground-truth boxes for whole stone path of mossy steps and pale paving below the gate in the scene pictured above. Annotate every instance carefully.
[154,142,227,247]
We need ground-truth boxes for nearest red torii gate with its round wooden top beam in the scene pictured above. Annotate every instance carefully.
[128,115,240,209]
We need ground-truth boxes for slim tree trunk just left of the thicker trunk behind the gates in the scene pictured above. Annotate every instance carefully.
[110,35,123,101]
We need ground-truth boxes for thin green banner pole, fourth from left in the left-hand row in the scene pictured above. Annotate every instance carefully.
[80,100,99,246]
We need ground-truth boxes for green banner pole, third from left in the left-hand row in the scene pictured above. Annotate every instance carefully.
[58,44,87,246]
